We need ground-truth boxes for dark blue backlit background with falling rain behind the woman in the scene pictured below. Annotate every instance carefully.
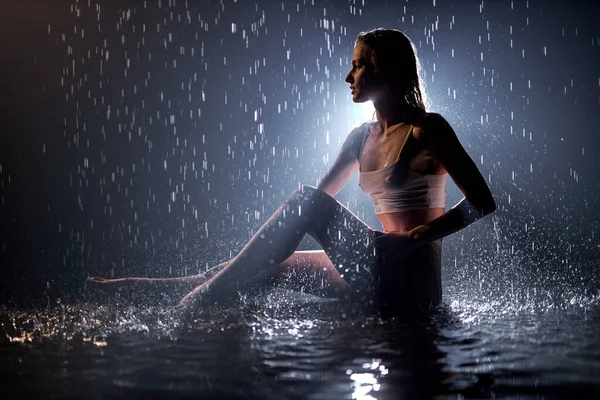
[0,0,600,305]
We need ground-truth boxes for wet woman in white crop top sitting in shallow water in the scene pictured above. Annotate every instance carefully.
[90,28,496,312]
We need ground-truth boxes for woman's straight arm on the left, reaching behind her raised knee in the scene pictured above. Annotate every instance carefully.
[317,126,364,197]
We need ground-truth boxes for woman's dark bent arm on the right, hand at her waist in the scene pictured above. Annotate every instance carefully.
[409,114,496,245]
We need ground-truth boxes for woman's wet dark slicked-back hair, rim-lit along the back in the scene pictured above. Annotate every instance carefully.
[356,28,427,111]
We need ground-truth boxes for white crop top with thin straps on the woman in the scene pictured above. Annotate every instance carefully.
[358,124,448,214]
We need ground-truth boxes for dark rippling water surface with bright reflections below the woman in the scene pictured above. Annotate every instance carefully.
[0,290,600,399]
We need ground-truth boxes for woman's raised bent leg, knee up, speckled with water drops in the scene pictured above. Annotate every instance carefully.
[180,186,380,307]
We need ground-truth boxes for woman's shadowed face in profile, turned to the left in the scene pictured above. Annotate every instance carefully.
[345,41,386,103]
